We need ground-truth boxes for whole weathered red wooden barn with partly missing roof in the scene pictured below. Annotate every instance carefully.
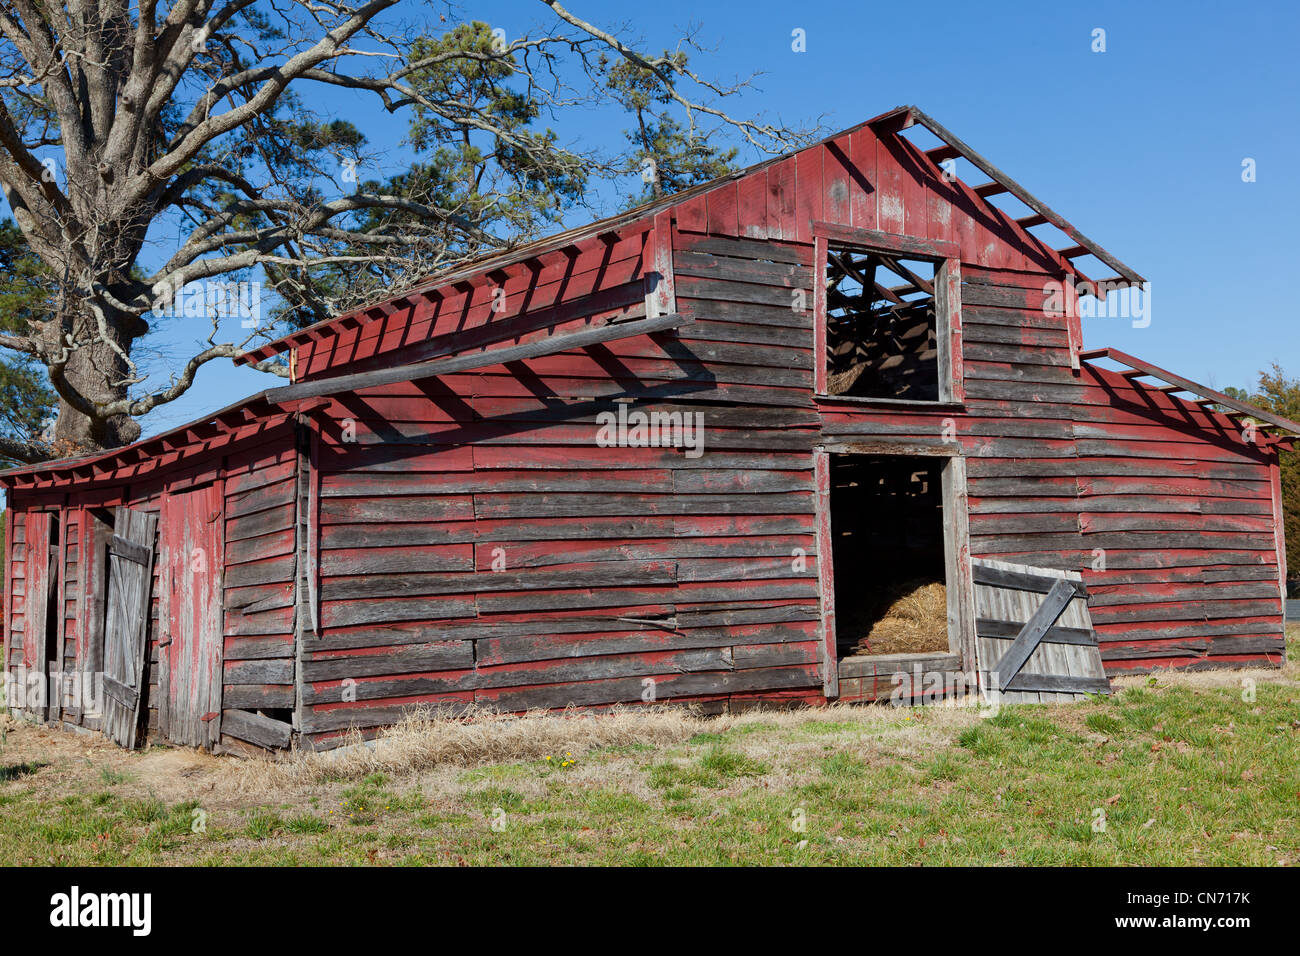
[0,108,1297,748]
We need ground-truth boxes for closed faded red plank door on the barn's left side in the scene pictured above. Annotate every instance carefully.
[159,484,224,749]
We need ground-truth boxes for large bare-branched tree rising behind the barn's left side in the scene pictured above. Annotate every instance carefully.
[0,0,809,460]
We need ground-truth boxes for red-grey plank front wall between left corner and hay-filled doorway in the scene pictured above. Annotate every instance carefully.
[302,291,820,745]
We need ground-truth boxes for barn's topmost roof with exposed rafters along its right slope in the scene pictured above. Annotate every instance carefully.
[234,107,1145,364]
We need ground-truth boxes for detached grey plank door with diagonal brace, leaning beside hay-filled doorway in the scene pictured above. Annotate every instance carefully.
[971,558,1110,704]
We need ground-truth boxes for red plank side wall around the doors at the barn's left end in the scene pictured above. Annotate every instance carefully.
[5,428,296,743]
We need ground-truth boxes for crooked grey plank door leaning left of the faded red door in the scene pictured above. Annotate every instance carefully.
[100,506,157,749]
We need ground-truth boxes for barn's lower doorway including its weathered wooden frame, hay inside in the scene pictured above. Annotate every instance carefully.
[819,444,974,700]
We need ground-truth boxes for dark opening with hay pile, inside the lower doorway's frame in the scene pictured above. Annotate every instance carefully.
[831,454,949,659]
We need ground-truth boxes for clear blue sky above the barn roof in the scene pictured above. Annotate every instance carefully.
[48,0,1300,432]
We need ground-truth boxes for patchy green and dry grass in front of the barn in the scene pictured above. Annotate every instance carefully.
[0,628,1300,865]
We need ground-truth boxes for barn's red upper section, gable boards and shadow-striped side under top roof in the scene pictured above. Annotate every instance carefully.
[237,107,1143,390]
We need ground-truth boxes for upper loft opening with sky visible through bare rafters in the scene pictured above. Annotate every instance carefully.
[826,243,940,402]
